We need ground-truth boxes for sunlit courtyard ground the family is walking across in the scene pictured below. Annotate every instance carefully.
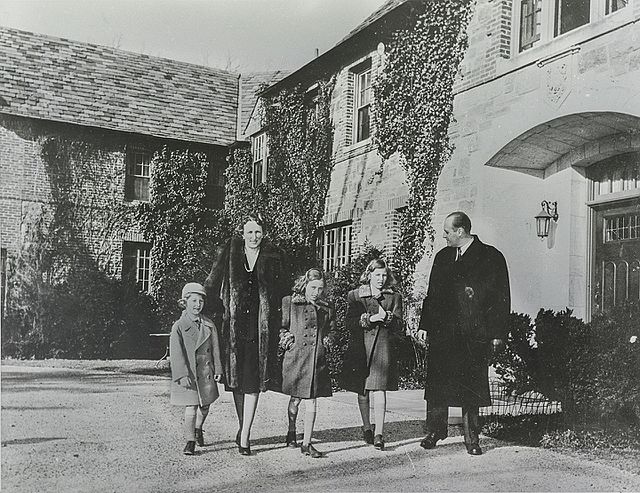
[1,365,640,492]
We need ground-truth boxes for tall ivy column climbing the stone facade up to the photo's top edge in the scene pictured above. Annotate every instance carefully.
[373,0,474,289]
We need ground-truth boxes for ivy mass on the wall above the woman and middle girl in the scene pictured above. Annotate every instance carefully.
[225,80,333,269]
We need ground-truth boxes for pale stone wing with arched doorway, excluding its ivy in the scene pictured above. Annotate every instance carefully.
[249,0,640,318]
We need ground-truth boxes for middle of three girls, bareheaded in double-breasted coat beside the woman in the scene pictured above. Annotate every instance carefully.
[280,269,336,459]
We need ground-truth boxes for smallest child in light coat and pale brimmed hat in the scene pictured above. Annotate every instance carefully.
[169,282,222,455]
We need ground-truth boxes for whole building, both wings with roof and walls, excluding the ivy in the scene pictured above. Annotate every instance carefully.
[0,0,640,319]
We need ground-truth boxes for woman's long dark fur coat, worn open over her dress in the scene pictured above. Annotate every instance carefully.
[204,236,288,391]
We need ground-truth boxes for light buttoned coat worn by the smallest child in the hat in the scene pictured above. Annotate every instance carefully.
[169,312,222,406]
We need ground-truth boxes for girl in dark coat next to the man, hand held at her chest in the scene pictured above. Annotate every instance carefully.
[342,259,403,450]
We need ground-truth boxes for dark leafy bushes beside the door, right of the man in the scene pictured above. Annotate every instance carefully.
[495,302,640,424]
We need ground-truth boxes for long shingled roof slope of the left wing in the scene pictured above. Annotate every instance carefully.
[0,27,239,145]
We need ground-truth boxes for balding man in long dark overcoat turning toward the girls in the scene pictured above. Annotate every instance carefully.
[418,212,511,455]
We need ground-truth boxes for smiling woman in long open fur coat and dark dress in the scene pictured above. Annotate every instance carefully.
[205,216,286,455]
